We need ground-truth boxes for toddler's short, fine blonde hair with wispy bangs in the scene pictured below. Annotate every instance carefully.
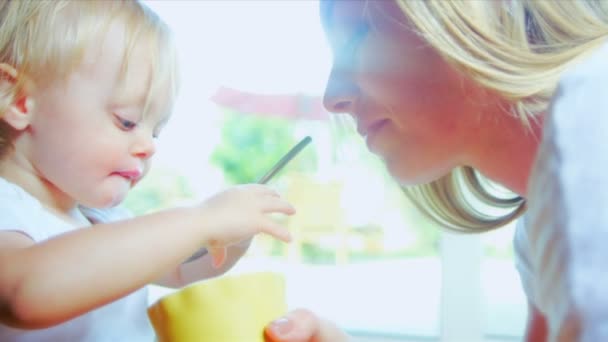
[0,0,178,158]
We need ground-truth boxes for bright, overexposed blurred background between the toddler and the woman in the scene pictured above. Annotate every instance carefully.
[131,0,527,342]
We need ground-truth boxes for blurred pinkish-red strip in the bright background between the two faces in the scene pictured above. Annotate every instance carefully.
[211,87,329,120]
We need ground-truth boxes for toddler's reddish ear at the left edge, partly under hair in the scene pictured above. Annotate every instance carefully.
[0,63,32,131]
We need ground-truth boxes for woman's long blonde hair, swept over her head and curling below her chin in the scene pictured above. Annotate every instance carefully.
[397,0,608,232]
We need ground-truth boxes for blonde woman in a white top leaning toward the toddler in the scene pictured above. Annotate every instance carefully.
[267,0,608,342]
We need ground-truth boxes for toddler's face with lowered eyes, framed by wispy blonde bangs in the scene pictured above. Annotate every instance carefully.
[26,24,171,207]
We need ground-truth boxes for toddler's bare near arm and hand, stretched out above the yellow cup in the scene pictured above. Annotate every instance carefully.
[0,185,294,329]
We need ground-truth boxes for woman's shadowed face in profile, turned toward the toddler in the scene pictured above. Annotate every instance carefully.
[323,1,490,184]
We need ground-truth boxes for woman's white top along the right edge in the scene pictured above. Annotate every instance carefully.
[514,40,608,342]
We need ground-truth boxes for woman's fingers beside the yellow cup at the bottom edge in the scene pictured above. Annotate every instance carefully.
[265,309,348,342]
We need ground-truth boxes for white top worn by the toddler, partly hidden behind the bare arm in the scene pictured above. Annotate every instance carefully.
[0,178,154,342]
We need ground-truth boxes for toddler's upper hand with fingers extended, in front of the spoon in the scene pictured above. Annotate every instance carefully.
[200,184,295,266]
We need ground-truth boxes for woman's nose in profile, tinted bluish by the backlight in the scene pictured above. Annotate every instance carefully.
[323,68,359,114]
